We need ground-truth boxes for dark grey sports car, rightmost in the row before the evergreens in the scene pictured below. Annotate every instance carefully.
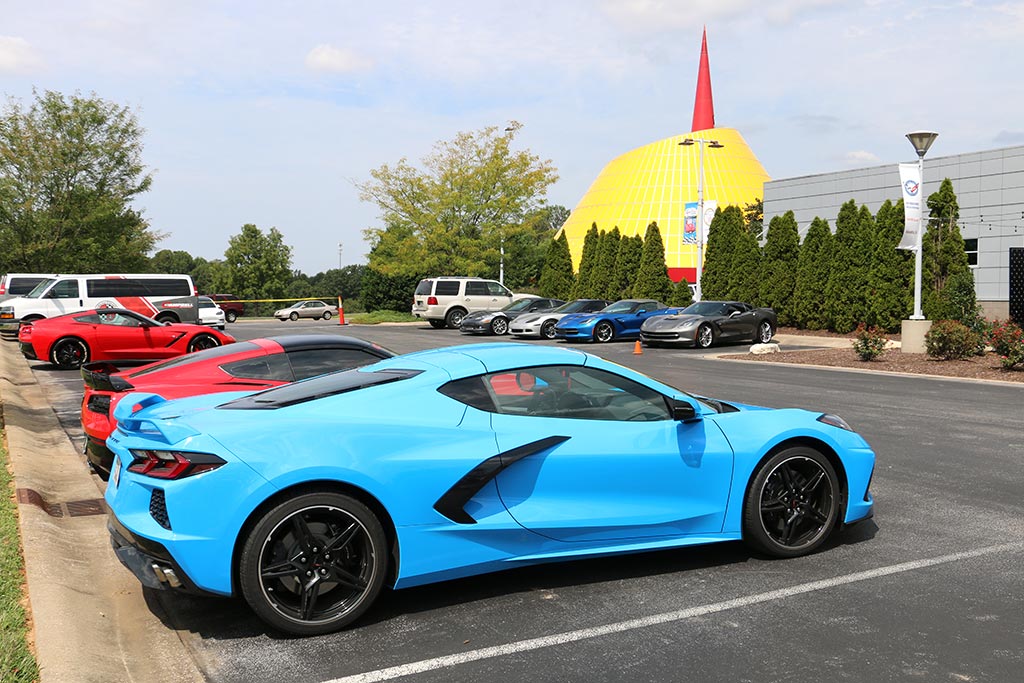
[640,301,778,348]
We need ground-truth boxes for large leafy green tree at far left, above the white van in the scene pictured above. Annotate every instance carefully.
[0,90,162,272]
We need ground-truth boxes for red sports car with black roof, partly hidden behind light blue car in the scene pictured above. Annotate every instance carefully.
[82,335,394,479]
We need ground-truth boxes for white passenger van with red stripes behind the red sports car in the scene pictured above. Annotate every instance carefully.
[0,273,199,332]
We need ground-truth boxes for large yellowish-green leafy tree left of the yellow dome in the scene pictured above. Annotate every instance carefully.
[357,123,558,280]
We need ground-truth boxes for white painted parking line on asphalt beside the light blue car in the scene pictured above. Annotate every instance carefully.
[325,542,1024,683]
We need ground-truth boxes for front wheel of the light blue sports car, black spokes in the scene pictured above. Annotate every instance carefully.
[743,446,840,557]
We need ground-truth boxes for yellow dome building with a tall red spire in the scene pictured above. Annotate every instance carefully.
[562,28,771,283]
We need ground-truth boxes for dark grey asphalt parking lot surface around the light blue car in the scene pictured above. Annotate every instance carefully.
[16,321,1024,682]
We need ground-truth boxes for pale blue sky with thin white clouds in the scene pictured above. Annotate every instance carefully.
[0,0,1024,274]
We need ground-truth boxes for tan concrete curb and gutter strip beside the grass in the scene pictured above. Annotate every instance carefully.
[0,344,204,683]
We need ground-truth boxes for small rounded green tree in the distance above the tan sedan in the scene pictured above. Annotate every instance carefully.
[214,223,301,299]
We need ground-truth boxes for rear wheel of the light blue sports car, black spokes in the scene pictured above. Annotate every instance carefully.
[239,492,388,636]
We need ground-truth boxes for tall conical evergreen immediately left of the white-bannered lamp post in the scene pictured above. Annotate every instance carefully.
[867,200,913,332]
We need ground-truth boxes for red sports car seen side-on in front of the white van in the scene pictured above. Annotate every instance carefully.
[17,308,234,370]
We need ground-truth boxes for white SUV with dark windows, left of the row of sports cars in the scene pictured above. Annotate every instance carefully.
[413,276,513,330]
